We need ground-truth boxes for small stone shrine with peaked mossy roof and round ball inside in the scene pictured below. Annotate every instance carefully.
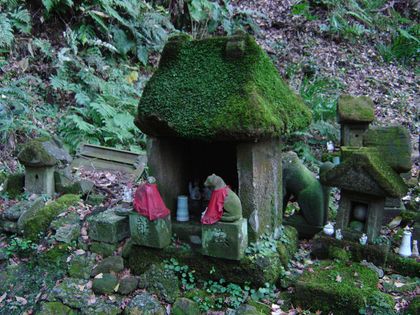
[321,147,407,242]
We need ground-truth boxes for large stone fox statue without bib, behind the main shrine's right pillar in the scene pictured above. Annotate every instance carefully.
[282,151,334,227]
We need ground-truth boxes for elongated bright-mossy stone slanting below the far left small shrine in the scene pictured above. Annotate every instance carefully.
[21,195,80,240]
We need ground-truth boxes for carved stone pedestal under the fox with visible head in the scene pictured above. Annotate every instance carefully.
[201,219,248,260]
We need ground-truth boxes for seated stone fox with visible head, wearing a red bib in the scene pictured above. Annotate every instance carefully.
[201,174,242,224]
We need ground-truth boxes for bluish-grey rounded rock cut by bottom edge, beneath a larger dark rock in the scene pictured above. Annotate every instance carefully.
[124,292,166,315]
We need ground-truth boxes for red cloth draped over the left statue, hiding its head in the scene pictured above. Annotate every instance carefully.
[133,183,170,221]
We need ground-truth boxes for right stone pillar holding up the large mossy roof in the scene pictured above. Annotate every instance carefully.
[237,139,283,241]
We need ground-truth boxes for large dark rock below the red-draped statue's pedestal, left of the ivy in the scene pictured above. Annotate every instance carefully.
[139,265,180,303]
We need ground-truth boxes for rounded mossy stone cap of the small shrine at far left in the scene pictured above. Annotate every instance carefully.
[18,138,58,166]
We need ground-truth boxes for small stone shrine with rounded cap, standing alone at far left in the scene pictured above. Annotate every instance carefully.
[18,139,58,196]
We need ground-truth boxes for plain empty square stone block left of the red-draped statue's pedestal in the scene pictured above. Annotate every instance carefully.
[88,209,130,243]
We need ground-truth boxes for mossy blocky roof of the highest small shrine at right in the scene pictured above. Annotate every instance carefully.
[337,95,375,123]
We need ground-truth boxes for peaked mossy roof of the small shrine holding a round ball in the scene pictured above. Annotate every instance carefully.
[321,147,407,197]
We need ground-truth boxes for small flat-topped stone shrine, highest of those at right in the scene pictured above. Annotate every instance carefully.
[337,95,375,147]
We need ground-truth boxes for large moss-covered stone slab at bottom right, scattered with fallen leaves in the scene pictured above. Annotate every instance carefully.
[293,262,389,315]
